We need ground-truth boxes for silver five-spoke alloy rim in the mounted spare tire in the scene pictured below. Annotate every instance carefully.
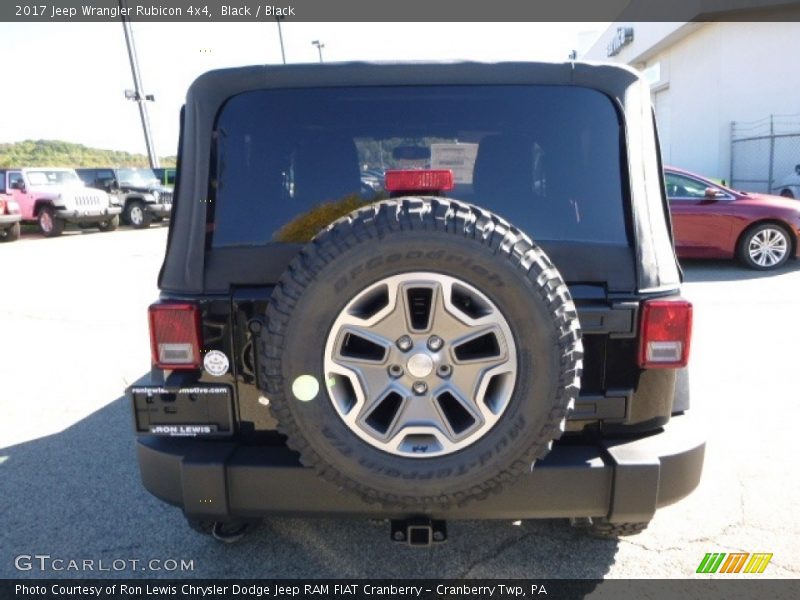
[324,272,517,458]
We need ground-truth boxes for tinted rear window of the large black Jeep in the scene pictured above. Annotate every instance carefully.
[210,85,628,247]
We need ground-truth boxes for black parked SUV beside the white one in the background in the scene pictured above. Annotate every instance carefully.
[75,167,172,229]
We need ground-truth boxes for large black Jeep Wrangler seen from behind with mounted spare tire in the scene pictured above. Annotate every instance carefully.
[128,63,704,544]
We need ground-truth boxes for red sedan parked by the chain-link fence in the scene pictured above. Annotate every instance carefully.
[664,167,800,270]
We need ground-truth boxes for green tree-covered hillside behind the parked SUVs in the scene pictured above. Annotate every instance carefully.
[0,140,175,167]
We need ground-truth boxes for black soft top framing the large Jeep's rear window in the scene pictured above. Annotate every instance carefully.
[159,62,680,294]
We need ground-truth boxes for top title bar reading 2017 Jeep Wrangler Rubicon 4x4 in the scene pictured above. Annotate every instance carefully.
[0,0,800,23]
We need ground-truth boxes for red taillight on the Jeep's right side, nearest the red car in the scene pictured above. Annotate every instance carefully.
[639,300,692,369]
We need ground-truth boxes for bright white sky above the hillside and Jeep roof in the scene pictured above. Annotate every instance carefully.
[0,21,608,156]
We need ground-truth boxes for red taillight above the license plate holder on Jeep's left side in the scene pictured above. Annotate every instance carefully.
[148,302,202,369]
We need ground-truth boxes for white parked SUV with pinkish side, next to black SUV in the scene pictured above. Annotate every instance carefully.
[0,167,120,237]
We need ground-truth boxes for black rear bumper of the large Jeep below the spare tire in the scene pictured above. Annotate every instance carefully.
[137,414,705,522]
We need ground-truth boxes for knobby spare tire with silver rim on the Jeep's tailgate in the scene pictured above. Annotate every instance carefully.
[259,198,582,509]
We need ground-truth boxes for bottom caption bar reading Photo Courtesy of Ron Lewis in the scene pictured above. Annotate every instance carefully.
[0,576,800,600]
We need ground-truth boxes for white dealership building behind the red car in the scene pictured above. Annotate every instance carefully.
[580,8,800,191]
